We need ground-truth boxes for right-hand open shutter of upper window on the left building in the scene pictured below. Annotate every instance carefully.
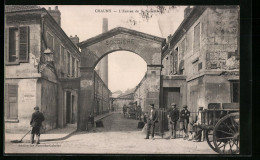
[19,26,29,62]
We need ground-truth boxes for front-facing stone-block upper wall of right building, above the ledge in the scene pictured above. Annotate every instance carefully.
[205,8,239,70]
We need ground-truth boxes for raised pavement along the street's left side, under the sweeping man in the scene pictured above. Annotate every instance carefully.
[5,112,113,143]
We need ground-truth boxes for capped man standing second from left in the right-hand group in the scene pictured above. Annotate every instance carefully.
[168,103,179,139]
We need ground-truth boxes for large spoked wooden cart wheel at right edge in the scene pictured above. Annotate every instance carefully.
[213,113,240,154]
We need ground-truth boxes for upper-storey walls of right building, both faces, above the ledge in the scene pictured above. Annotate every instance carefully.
[162,7,239,79]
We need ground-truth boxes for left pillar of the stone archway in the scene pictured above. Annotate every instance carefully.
[77,67,94,131]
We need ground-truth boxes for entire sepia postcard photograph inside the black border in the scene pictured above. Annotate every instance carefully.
[3,5,240,155]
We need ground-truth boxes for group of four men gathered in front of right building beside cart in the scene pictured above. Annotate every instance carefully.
[144,103,203,142]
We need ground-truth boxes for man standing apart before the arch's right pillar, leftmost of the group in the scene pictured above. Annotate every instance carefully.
[145,104,158,140]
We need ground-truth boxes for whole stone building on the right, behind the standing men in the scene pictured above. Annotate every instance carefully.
[160,6,240,120]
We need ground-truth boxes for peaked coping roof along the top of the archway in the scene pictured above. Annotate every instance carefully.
[78,27,164,47]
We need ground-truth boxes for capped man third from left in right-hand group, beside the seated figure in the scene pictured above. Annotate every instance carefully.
[180,105,190,139]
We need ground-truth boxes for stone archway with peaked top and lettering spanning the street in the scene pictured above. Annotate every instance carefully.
[78,27,164,130]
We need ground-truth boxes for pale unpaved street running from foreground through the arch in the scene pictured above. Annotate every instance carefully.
[5,113,216,154]
